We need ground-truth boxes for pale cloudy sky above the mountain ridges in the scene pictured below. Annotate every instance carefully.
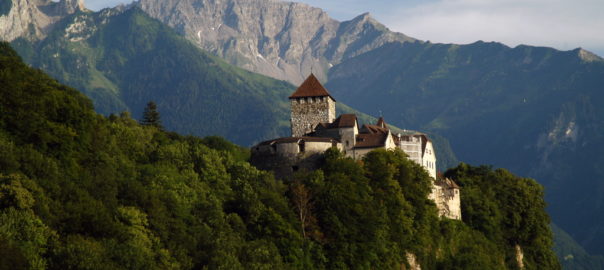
[85,0,604,56]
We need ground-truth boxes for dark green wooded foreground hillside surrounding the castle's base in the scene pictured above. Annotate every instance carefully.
[0,43,560,269]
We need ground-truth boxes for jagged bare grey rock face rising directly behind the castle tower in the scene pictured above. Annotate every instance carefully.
[139,0,414,84]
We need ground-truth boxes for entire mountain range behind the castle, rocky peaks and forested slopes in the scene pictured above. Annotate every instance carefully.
[0,0,604,269]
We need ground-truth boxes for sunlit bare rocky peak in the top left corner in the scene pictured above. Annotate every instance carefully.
[0,0,84,41]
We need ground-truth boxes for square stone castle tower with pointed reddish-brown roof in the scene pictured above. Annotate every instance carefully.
[289,73,336,137]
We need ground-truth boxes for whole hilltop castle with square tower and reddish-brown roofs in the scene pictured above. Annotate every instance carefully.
[251,74,461,219]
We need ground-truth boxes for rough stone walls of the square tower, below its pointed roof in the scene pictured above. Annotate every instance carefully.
[291,97,336,137]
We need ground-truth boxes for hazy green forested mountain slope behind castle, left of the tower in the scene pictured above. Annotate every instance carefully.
[12,7,416,152]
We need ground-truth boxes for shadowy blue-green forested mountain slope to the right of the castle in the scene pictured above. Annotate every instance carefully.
[327,42,604,254]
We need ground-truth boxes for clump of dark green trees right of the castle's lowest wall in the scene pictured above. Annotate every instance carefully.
[445,163,560,269]
